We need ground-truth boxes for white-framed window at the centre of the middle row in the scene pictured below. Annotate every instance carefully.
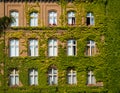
[48,39,57,56]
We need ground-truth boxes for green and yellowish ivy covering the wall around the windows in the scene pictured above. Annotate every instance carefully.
[0,0,117,93]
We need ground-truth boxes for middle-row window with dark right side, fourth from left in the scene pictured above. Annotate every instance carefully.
[67,40,76,56]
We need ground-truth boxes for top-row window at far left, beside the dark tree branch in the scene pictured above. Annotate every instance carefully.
[10,11,19,27]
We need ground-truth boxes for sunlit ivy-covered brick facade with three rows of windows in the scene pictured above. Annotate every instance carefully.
[0,0,106,93]
